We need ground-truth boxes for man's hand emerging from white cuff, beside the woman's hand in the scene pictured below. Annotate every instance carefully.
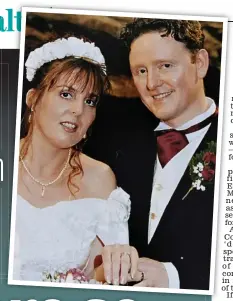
[134,257,169,288]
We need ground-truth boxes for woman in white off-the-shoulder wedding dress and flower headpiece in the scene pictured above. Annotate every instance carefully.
[13,37,130,282]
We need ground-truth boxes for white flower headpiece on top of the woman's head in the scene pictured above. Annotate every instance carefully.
[25,37,106,81]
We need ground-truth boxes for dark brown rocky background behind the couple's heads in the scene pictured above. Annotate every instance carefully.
[25,13,222,98]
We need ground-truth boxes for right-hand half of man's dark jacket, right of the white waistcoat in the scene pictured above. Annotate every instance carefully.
[146,118,217,290]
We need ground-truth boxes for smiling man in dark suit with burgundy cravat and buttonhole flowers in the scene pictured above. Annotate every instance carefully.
[85,19,217,290]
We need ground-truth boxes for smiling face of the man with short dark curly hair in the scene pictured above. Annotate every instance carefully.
[129,32,207,126]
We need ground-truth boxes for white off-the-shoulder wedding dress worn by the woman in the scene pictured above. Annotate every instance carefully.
[13,188,130,281]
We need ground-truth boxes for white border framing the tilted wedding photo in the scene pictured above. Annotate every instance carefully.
[8,7,228,295]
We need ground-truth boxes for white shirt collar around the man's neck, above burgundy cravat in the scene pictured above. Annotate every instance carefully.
[155,97,216,131]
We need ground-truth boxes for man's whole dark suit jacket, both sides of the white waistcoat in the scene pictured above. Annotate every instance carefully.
[85,99,217,290]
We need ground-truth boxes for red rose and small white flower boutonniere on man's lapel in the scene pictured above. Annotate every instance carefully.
[183,141,216,200]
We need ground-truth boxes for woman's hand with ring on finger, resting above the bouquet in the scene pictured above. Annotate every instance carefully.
[102,245,141,285]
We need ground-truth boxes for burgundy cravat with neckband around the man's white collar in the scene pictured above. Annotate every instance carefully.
[155,110,218,167]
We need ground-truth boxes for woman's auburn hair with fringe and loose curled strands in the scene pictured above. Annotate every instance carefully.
[20,36,110,195]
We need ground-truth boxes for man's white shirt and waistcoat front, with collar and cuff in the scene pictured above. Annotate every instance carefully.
[148,98,216,288]
